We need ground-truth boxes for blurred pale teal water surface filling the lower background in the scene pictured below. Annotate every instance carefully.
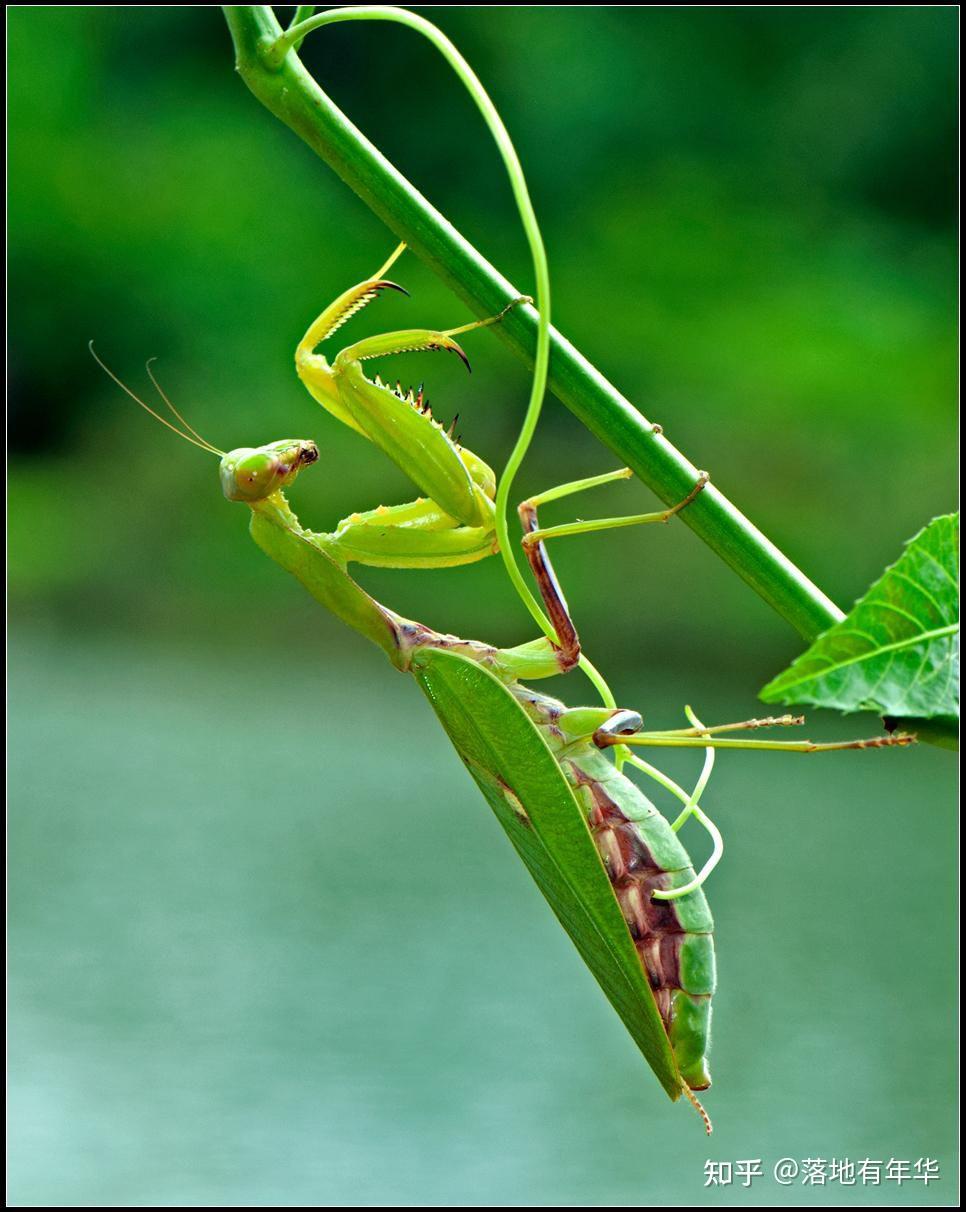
[10,628,956,1207]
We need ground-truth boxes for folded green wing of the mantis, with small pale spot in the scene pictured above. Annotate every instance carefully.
[412,650,682,1099]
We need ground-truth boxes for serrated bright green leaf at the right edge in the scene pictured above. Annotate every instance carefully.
[761,514,959,721]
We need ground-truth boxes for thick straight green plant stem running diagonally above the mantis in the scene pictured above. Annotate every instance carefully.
[224,5,844,640]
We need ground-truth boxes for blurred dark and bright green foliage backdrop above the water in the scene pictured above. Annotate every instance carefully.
[10,7,955,673]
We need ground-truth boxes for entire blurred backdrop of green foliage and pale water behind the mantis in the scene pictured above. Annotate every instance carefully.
[8,6,958,1206]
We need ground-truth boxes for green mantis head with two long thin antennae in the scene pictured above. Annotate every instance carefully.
[88,342,319,504]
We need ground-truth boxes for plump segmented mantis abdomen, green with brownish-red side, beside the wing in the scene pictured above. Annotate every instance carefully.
[516,686,715,1090]
